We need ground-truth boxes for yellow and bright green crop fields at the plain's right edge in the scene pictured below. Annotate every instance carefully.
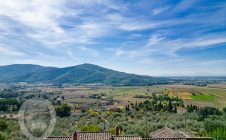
[162,85,226,108]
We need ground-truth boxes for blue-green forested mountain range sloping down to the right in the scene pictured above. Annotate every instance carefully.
[0,64,170,85]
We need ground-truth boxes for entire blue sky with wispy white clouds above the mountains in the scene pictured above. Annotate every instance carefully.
[0,0,226,76]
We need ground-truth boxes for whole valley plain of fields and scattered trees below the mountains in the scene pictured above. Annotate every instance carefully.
[0,84,226,140]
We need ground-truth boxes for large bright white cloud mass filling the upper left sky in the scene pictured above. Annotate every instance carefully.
[0,0,120,47]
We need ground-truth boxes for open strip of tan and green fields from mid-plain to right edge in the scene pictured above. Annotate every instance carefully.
[55,84,226,109]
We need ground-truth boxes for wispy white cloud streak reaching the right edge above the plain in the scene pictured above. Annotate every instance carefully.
[112,34,226,63]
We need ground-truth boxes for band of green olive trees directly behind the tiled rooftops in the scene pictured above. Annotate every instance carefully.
[1,110,226,140]
